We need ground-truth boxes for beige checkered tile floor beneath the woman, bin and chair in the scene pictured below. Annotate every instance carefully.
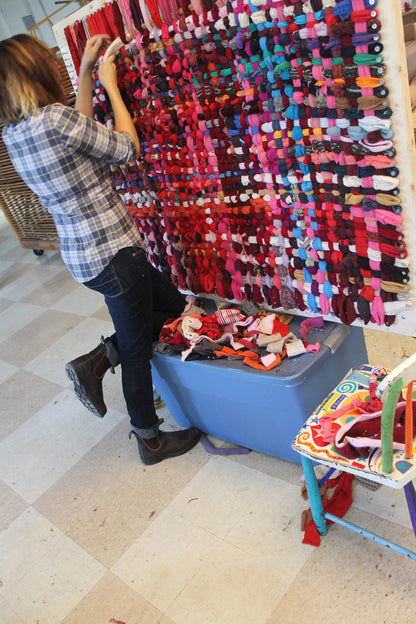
[0,211,416,624]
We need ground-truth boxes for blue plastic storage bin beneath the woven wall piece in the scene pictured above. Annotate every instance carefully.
[152,317,367,462]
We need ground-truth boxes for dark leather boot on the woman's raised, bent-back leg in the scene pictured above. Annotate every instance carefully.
[65,337,118,418]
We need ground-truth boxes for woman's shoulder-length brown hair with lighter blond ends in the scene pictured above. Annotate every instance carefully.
[0,34,66,123]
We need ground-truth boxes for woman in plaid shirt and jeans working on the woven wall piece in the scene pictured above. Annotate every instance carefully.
[0,35,200,464]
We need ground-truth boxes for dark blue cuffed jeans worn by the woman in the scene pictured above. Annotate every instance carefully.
[85,247,186,439]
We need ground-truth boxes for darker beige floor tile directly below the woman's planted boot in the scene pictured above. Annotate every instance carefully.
[34,457,188,567]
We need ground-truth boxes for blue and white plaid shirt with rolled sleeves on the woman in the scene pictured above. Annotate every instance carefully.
[3,104,143,282]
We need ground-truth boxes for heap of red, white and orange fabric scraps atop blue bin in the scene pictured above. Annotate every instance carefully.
[155,306,324,371]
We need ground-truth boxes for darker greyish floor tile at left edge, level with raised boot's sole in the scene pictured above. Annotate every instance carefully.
[0,370,62,440]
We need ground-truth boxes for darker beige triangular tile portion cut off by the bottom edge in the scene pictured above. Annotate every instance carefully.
[60,573,173,624]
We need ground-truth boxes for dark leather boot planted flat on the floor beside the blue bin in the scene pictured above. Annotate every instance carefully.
[129,418,201,466]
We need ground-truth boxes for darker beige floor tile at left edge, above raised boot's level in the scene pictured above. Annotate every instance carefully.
[1,310,84,368]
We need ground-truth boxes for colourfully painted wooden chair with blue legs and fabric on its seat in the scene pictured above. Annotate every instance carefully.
[292,354,416,560]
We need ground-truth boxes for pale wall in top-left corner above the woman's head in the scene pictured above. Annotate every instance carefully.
[0,0,82,47]
